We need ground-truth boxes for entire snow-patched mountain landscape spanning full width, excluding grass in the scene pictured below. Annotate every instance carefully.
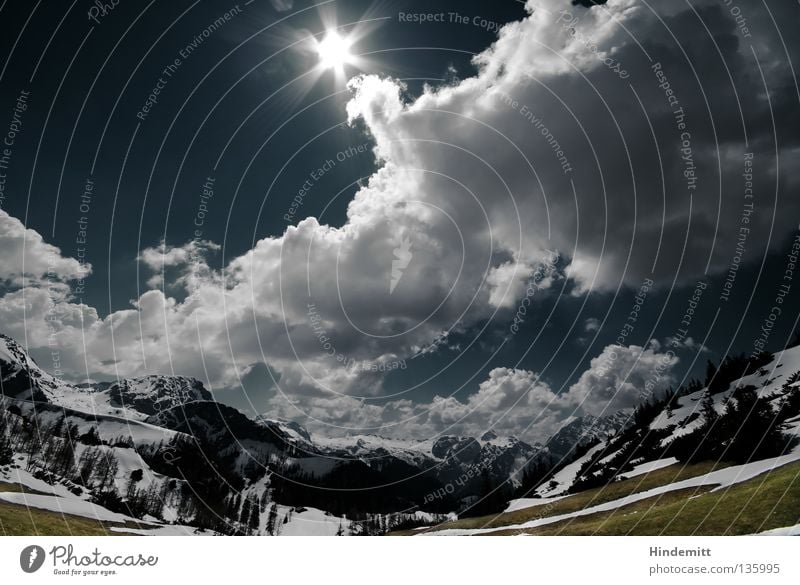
[0,328,800,534]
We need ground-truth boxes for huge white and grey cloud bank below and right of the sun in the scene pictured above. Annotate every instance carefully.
[0,0,800,434]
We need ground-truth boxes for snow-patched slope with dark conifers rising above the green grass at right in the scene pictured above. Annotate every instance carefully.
[533,346,800,497]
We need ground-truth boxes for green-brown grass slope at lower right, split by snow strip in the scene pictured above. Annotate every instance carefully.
[396,463,800,536]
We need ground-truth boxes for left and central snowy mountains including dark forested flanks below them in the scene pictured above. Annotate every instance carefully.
[0,336,540,528]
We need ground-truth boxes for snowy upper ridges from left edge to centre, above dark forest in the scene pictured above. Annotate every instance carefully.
[0,335,539,481]
